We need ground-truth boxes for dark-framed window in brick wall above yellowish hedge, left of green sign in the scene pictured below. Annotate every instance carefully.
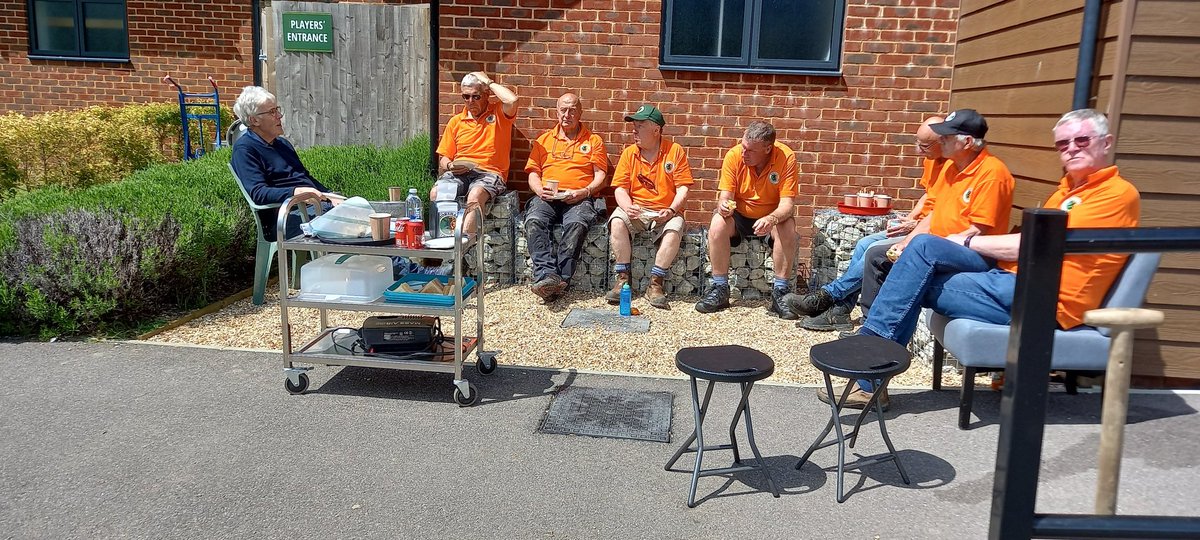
[29,0,130,60]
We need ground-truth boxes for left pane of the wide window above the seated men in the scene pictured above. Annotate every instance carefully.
[671,0,739,58]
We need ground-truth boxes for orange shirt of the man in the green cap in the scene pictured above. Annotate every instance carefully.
[612,137,692,210]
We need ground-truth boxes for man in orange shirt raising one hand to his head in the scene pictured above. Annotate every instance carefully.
[430,71,517,234]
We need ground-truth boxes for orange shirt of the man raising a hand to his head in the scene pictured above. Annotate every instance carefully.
[438,101,516,181]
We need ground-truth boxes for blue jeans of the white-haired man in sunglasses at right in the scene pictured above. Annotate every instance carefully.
[863,234,1016,346]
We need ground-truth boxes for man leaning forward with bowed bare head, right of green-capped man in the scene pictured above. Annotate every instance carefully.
[696,121,799,319]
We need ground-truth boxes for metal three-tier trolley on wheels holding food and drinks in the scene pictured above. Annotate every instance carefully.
[276,194,497,407]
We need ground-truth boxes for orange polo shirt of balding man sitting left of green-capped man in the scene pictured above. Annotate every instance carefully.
[526,126,608,190]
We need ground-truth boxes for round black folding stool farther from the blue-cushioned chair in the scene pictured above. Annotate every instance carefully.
[664,346,779,508]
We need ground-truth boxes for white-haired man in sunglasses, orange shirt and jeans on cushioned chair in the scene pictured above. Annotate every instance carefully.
[840,109,1140,410]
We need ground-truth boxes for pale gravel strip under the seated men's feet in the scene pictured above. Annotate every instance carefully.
[148,286,960,388]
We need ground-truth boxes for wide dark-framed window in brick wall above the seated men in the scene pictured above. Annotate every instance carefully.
[659,0,846,74]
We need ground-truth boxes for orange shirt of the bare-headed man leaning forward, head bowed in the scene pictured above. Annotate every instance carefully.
[718,140,799,220]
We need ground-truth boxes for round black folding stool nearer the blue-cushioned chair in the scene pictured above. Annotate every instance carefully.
[796,336,910,503]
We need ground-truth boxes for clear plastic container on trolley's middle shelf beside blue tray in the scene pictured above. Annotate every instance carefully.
[300,253,396,302]
